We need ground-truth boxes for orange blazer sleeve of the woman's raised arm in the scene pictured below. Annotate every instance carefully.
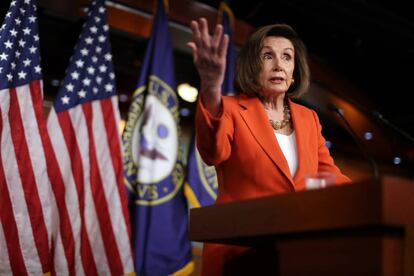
[195,97,234,166]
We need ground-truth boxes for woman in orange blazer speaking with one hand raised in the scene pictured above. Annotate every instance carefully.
[188,18,350,275]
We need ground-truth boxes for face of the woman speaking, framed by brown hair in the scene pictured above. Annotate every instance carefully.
[259,36,295,97]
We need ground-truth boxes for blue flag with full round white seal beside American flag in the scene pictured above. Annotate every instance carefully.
[123,1,194,275]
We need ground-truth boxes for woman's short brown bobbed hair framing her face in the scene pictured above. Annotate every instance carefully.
[234,24,310,97]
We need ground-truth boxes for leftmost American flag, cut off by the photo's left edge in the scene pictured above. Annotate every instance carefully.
[0,0,53,275]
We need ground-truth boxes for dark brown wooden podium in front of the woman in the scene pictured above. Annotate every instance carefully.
[189,176,414,276]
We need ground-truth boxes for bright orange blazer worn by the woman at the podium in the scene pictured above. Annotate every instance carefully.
[196,95,350,276]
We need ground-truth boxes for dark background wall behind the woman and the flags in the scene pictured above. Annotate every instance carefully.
[0,0,414,178]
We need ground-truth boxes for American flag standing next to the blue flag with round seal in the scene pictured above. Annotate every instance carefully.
[47,0,134,275]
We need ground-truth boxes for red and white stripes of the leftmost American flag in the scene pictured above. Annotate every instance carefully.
[0,81,52,275]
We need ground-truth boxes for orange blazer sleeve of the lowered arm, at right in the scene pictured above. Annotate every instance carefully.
[312,110,351,184]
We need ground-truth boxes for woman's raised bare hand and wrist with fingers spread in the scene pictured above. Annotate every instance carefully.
[187,18,229,115]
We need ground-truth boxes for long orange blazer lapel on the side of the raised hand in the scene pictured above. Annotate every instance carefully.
[239,96,293,185]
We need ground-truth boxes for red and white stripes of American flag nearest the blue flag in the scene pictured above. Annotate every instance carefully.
[47,97,134,275]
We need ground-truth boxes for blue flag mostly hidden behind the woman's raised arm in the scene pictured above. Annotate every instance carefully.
[186,2,235,207]
